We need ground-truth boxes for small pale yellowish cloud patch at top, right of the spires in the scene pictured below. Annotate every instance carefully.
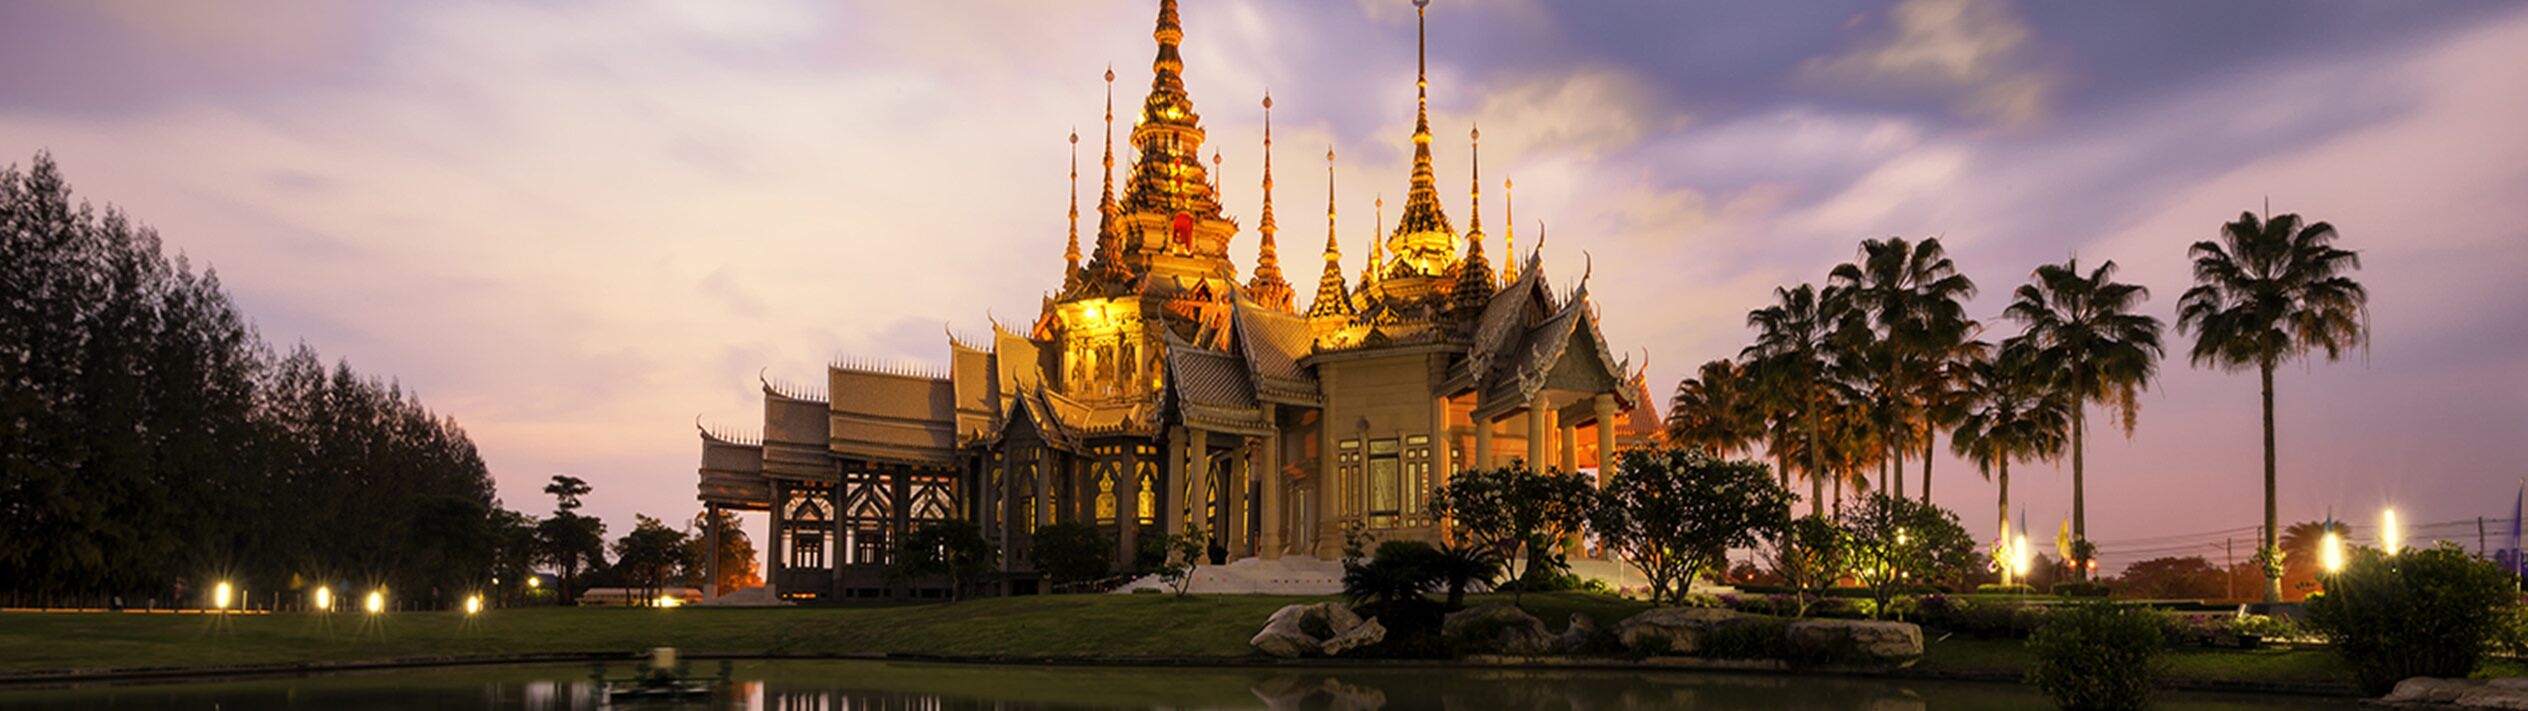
[1800,0,2058,127]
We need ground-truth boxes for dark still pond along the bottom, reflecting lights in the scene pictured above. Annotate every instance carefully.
[0,660,2356,711]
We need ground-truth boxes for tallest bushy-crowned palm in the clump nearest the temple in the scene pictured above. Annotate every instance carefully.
[1828,238,1974,496]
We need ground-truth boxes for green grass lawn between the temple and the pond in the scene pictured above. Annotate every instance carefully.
[0,592,2467,686]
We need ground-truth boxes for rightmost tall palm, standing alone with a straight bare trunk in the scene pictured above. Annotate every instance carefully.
[2177,213,2369,602]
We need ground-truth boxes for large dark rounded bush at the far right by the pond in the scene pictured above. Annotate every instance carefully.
[2308,544,2518,696]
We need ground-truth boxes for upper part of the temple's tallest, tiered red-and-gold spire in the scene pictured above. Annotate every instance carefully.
[1125,0,1221,220]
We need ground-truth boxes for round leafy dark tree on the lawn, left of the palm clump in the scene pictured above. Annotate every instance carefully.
[1590,448,1792,605]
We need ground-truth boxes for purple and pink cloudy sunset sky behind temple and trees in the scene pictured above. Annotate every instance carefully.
[0,0,2528,569]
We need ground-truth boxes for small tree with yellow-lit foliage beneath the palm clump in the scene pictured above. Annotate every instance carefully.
[1838,493,1974,612]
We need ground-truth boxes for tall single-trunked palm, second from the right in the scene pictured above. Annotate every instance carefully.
[2002,258,2164,579]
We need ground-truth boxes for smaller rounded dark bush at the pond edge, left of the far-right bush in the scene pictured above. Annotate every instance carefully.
[2027,602,2166,711]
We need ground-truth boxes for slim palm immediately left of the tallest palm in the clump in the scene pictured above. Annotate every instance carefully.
[1739,283,1843,514]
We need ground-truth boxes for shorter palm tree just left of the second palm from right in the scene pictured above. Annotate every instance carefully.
[1949,342,2070,584]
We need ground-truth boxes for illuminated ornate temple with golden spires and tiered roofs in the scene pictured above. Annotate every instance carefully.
[700,0,1658,600]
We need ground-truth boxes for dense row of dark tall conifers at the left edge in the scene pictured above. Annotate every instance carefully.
[0,154,513,605]
